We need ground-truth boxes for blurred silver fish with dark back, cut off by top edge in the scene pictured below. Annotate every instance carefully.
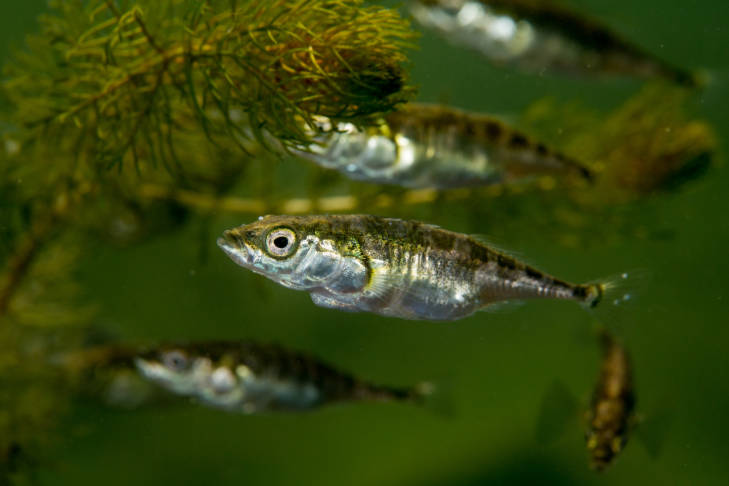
[410,0,697,86]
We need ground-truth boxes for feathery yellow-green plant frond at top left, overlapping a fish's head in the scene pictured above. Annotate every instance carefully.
[4,0,413,175]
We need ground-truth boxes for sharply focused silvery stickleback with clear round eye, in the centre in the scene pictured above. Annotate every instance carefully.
[218,215,610,320]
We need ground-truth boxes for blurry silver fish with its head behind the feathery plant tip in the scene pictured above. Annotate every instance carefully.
[296,103,592,189]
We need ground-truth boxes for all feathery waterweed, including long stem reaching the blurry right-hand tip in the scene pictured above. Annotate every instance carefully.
[0,0,715,484]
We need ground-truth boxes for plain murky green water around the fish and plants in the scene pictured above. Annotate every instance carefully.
[0,0,729,486]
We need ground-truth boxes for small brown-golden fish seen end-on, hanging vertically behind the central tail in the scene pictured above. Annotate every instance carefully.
[586,331,636,470]
